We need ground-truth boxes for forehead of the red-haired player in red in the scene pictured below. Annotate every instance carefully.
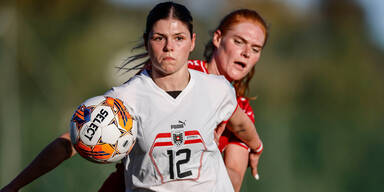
[225,22,265,45]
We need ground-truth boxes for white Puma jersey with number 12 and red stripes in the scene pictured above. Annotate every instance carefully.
[106,70,237,192]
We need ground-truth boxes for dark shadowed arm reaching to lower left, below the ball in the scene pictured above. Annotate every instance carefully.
[1,132,76,192]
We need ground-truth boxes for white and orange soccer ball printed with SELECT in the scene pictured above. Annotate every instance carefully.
[70,96,137,163]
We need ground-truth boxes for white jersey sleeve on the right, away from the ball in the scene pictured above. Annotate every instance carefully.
[217,77,237,122]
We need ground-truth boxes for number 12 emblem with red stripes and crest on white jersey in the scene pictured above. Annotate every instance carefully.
[149,130,207,183]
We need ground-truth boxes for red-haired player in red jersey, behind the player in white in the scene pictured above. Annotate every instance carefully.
[189,9,268,191]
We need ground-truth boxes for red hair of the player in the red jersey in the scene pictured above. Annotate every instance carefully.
[204,9,268,97]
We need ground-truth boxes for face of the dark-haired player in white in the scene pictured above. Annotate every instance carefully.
[146,18,195,75]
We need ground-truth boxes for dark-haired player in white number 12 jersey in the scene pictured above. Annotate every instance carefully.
[0,2,260,191]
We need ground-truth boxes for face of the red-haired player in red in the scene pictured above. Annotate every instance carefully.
[213,22,265,81]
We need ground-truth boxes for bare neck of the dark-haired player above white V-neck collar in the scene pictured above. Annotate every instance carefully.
[151,68,190,91]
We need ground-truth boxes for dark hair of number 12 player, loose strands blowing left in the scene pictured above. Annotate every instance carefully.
[118,2,193,72]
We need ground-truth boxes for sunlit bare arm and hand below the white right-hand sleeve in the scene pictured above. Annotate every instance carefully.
[227,108,263,179]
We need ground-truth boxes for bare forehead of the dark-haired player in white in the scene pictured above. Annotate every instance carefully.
[152,18,189,34]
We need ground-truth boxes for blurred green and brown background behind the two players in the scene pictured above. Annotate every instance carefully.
[0,0,384,192]
